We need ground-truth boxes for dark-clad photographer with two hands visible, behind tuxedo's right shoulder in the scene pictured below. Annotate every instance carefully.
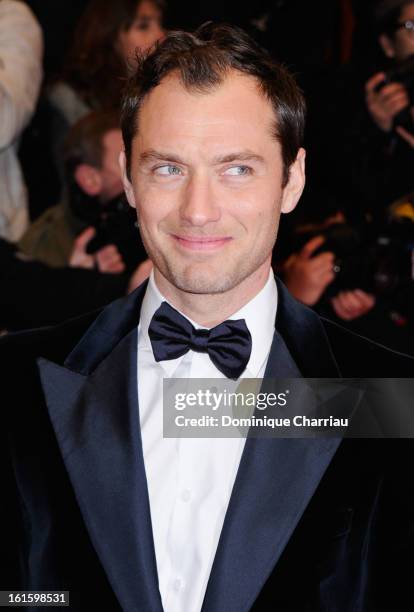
[273,201,414,354]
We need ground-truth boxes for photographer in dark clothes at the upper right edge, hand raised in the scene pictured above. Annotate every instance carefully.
[348,0,414,218]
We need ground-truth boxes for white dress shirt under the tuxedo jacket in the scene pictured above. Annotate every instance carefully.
[138,271,277,612]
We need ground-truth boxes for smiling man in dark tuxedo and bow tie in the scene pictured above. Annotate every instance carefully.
[1,24,413,612]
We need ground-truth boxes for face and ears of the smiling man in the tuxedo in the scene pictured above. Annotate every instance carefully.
[121,73,304,294]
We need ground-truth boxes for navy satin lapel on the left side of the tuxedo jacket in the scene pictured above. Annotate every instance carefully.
[38,328,162,612]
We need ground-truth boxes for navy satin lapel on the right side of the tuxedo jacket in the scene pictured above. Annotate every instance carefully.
[202,287,340,612]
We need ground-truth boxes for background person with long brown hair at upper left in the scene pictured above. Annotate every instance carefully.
[48,0,165,184]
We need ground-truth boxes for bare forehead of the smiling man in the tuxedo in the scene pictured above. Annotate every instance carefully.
[134,73,278,154]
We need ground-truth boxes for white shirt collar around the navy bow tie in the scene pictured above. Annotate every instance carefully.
[138,269,278,378]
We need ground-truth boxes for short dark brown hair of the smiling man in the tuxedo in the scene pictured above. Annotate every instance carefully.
[121,23,305,185]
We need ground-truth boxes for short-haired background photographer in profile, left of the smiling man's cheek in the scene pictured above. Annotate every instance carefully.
[19,112,145,271]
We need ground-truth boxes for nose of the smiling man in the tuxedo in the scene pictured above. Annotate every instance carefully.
[180,176,221,227]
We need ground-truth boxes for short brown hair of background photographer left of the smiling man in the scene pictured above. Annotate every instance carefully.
[63,111,120,177]
